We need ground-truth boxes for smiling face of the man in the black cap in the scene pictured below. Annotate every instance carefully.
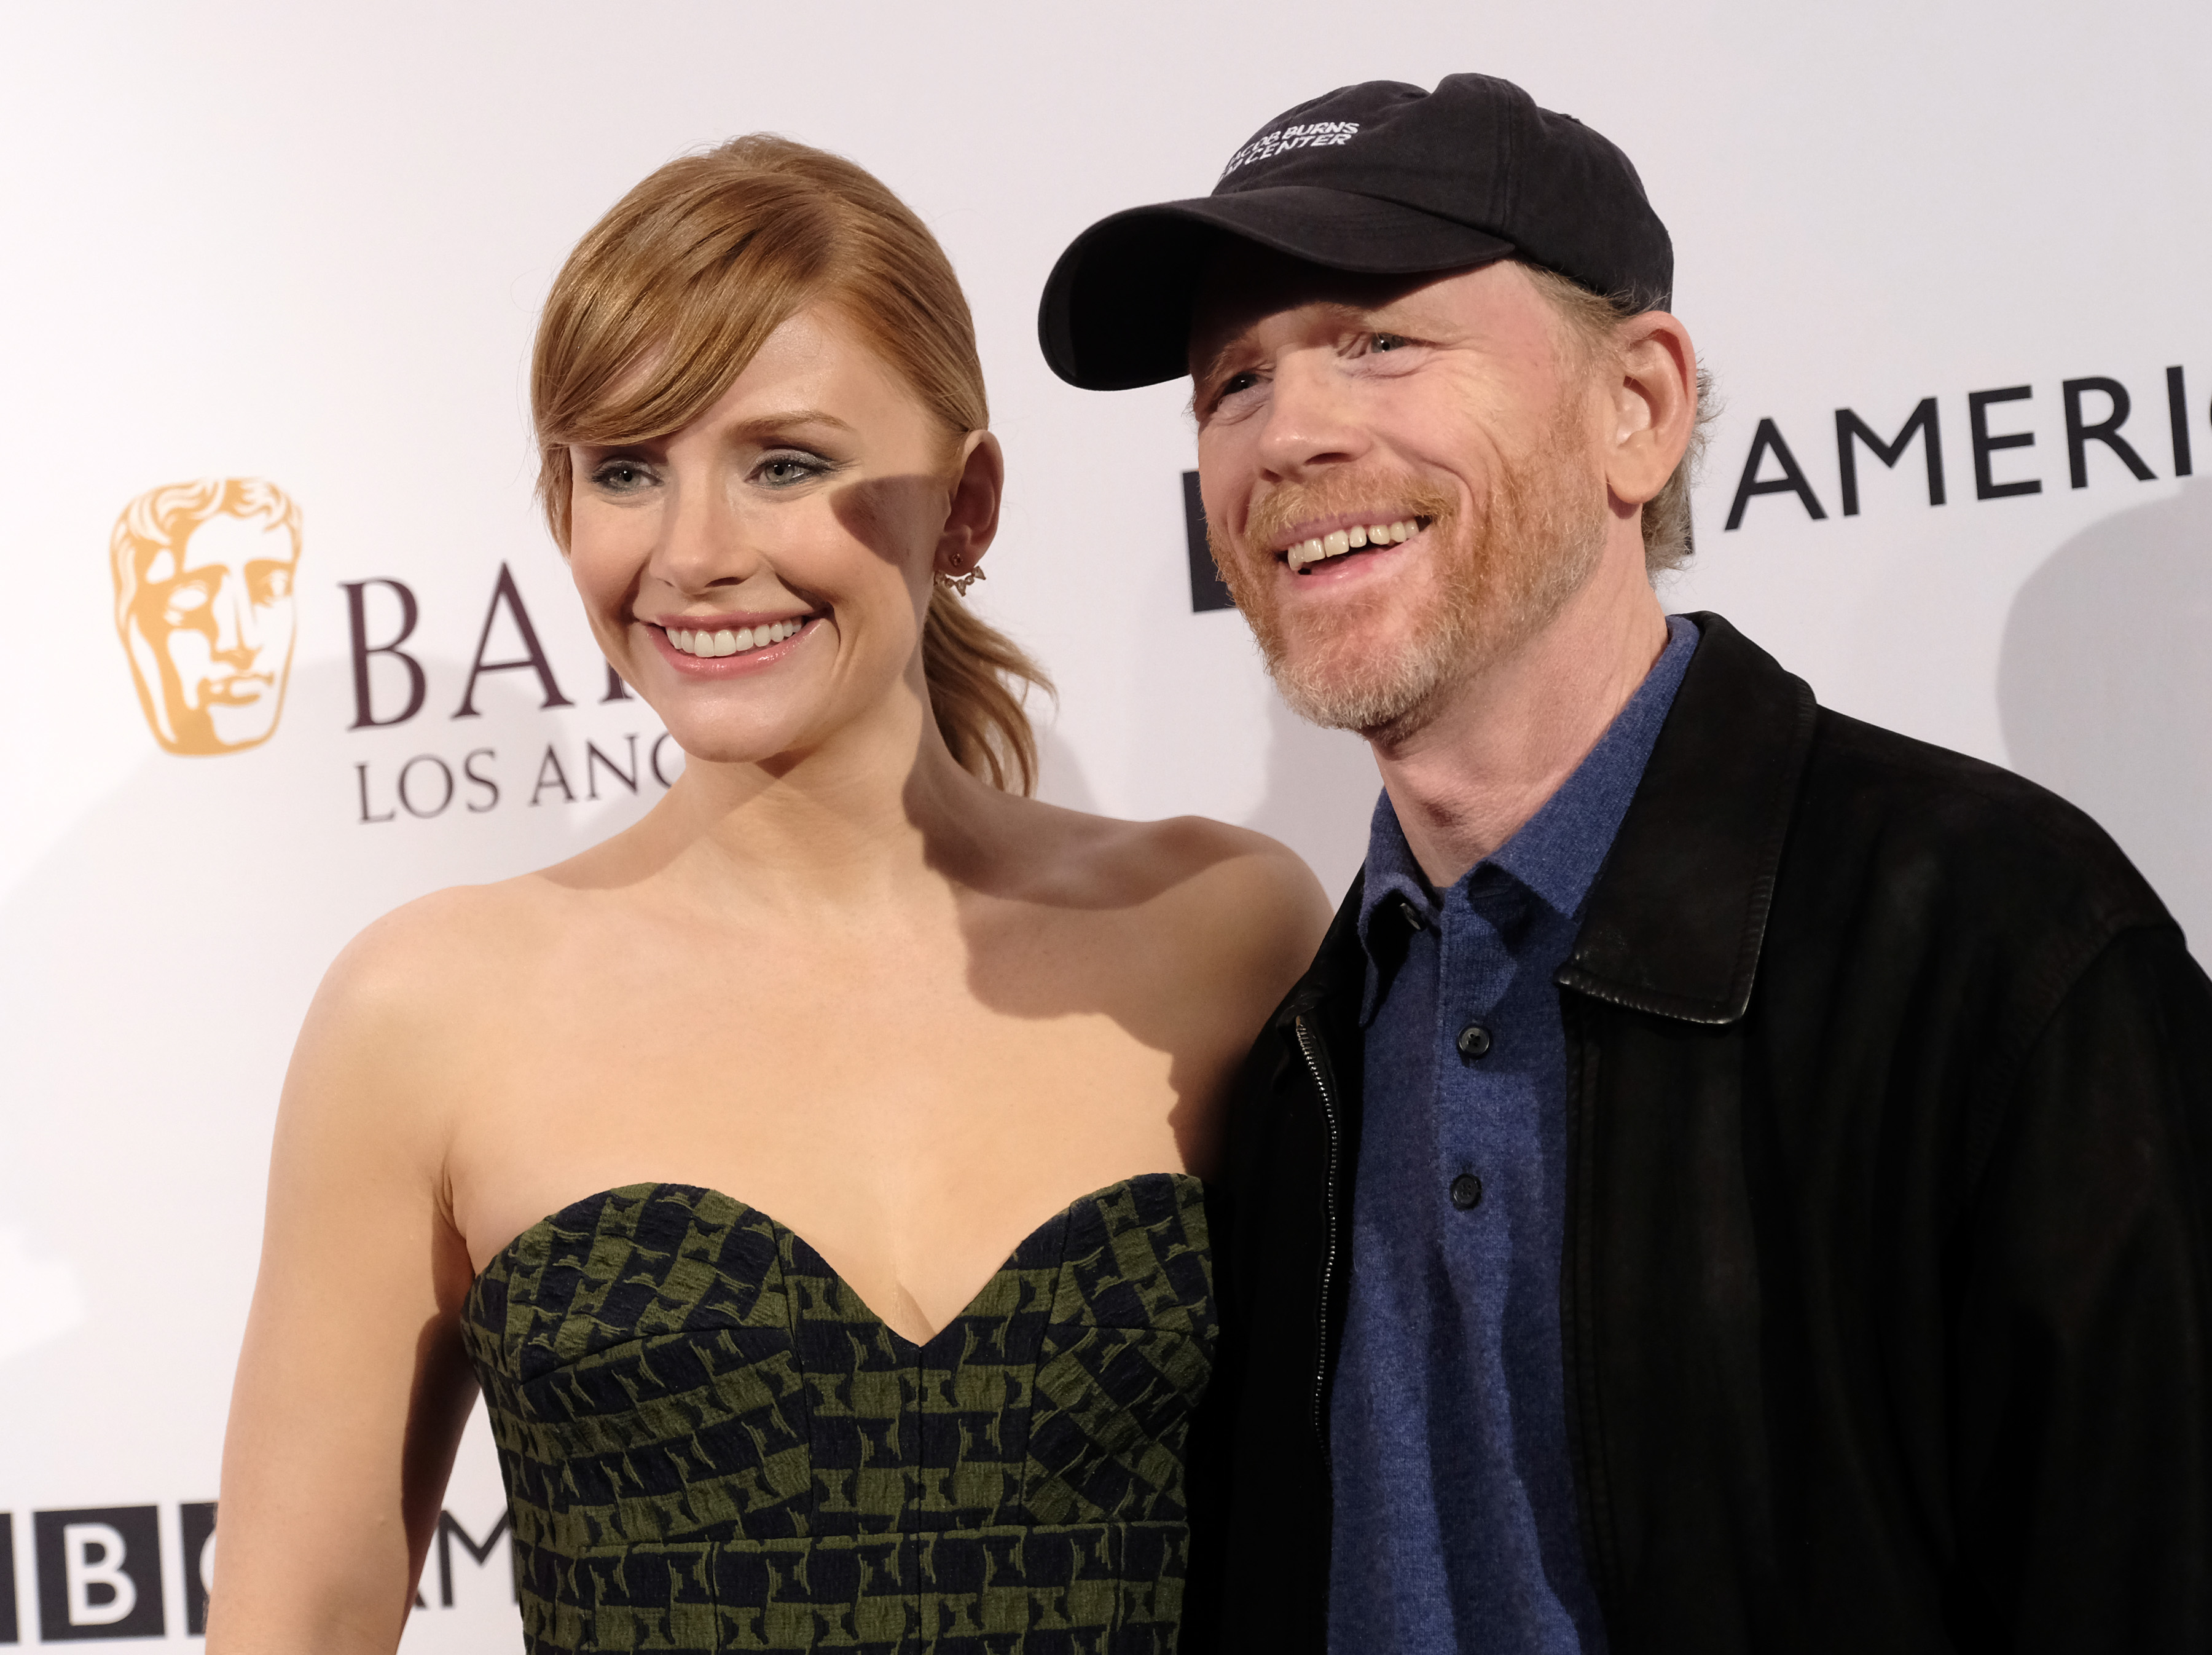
[1190,243,1606,739]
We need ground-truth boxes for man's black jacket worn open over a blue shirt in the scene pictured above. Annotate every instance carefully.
[1190,615,2212,1655]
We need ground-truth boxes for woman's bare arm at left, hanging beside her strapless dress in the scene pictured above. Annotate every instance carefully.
[208,916,476,1655]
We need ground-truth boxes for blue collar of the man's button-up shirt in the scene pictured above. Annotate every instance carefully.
[1358,615,1696,1024]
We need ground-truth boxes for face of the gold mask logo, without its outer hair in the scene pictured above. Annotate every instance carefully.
[130,516,296,752]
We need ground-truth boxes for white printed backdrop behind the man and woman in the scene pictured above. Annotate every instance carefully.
[0,0,2212,1651]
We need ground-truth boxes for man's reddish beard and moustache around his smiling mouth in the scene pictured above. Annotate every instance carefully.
[1212,405,1606,744]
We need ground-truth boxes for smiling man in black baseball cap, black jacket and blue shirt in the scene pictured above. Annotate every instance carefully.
[1040,75,2212,1655]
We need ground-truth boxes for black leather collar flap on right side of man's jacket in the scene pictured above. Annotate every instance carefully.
[1555,613,1816,1024]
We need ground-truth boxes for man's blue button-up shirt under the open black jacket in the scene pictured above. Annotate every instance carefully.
[1330,615,1696,1655]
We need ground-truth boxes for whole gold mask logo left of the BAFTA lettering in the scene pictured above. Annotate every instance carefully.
[108,478,301,752]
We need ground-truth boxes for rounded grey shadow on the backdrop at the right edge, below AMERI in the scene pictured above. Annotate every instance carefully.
[1998,480,2212,958]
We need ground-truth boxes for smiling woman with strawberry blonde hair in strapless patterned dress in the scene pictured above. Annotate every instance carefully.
[208,137,1327,1655]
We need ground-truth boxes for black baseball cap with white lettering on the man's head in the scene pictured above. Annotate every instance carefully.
[1037,75,1674,391]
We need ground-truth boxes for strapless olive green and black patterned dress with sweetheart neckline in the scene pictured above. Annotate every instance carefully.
[462,1173,1214,1655]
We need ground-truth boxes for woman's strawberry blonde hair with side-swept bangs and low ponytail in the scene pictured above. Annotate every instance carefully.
[531,133,1051,792]
